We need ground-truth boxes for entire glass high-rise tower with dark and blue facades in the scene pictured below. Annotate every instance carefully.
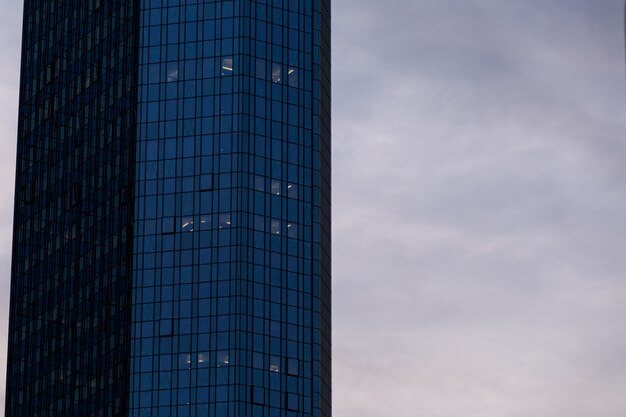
[5,0,331,417]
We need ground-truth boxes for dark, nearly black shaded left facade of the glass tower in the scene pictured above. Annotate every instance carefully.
[6,0,137,417]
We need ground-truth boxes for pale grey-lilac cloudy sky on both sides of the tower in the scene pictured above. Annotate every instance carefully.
[0,0,626,417]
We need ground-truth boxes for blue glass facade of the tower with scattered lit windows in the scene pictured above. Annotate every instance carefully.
[130,0,330,417]
